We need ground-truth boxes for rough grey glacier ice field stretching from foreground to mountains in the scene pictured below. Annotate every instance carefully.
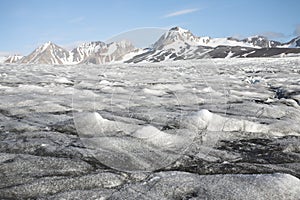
[0,58,300,200]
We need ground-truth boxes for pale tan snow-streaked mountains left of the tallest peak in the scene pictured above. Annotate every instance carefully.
[16,41,140,65]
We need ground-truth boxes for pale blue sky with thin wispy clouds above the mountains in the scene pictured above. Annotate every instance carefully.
[0,0,300,55]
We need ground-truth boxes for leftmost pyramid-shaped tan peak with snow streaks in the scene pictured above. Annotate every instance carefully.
[19,42,70,65]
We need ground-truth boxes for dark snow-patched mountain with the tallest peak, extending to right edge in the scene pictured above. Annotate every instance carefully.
[127,27,300,63]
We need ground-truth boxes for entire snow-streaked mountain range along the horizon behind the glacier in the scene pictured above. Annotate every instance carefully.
[4,27,300,65]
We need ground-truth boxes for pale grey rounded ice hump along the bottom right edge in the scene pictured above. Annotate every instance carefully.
[113,172,300,200]
